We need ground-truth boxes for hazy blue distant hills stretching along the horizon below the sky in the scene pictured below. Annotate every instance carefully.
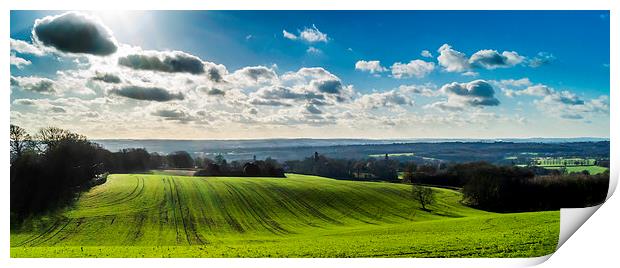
[94,137,609,161]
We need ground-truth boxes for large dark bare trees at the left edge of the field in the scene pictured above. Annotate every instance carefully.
[10,125,103,221]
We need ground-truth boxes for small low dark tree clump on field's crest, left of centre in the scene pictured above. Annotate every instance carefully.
[194,155,285,177]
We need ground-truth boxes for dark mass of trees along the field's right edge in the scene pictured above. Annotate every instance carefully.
[403,162,609,212]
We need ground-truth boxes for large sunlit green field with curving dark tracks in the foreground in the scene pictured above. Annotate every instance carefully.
[11,174,560,257]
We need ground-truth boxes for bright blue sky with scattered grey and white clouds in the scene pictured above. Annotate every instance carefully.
[10,11,610,139]
